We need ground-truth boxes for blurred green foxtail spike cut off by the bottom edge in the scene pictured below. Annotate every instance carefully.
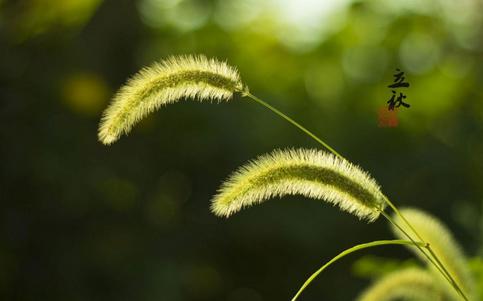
[356,268,446,301]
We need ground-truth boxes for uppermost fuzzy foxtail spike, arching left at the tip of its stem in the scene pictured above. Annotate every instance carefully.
[98,55,247,144]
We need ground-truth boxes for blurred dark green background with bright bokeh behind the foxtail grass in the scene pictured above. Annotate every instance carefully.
[0,0,483,301]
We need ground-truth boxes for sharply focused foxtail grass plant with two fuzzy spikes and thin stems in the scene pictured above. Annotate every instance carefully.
[98,55,476,301]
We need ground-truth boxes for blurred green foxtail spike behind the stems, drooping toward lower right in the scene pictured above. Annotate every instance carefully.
[392,208,477,300]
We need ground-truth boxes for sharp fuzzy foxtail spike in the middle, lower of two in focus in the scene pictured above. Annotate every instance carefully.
[211,149,385,221]
